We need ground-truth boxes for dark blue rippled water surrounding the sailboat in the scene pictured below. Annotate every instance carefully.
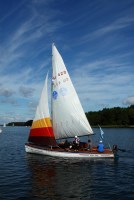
[0,127,134,200]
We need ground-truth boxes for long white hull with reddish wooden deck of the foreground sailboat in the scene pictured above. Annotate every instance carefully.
[25,144,114,158]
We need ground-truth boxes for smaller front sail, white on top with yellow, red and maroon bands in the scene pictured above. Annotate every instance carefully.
[28,76,57,146]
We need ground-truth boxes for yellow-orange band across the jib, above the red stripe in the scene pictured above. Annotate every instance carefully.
[32,118,52,129]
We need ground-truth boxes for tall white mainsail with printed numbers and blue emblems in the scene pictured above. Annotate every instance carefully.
[52,44,93,139]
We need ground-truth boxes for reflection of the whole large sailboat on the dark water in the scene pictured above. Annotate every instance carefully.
[26,154,114,200]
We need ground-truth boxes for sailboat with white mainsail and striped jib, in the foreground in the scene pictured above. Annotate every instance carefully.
[25,44,114,158]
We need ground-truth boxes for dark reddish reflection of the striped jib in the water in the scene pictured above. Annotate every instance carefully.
[26,154,61,200]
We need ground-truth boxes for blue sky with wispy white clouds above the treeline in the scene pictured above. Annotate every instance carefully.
[0,0,134,124]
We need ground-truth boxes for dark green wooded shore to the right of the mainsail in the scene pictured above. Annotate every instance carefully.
[86,105,134,127]
